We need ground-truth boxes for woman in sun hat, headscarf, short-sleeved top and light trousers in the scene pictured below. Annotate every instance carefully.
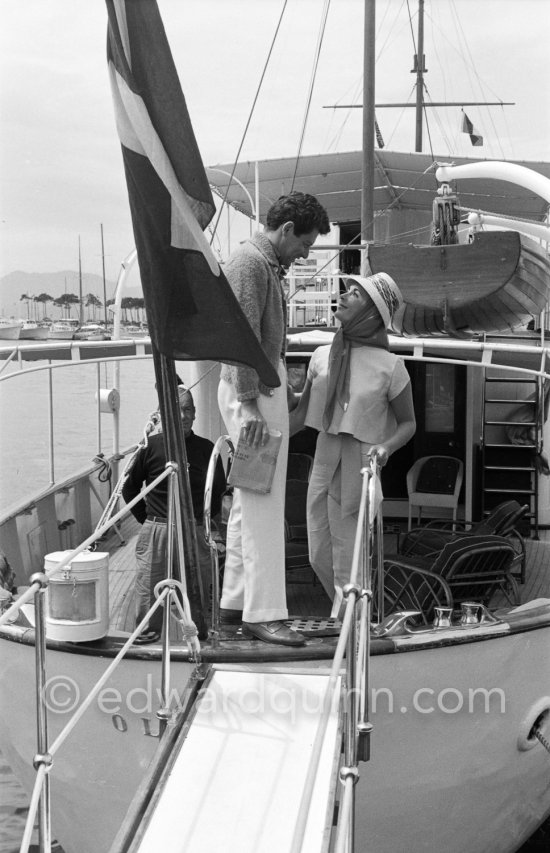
[291,273,416,615]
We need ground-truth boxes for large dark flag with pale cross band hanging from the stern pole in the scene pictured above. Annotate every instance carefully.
[106,0,280,387]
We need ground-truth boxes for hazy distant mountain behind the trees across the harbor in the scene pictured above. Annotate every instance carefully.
[0,270,141,317]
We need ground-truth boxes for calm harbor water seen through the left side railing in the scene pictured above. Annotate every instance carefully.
[0,340,156,514]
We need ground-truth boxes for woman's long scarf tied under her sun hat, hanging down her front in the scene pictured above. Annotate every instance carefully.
[323,305,389,430]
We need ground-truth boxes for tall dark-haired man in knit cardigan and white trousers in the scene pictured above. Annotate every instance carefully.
[218,192,330,646]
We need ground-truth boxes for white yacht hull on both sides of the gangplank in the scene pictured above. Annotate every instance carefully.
[0,602,550,853]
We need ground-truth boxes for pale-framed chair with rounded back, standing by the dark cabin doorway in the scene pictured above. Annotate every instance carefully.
[407,456,464,530]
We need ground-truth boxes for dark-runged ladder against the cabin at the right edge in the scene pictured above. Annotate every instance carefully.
[481,336,546,539]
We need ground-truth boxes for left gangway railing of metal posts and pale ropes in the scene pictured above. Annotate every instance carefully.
[0,462,205,853]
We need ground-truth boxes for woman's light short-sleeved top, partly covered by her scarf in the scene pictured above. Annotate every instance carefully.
[305,346,410,444]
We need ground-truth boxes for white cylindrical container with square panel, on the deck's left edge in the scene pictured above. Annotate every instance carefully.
[44,551,109,643]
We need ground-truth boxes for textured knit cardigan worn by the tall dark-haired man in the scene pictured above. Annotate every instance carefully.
[221,232,286,400]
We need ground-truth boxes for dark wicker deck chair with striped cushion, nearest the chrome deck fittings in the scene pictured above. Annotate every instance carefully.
[380,535,520,624]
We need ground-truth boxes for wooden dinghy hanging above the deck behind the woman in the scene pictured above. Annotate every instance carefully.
[368,231,550,337]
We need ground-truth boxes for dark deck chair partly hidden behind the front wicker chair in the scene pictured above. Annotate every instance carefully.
[397,500,529,583]
